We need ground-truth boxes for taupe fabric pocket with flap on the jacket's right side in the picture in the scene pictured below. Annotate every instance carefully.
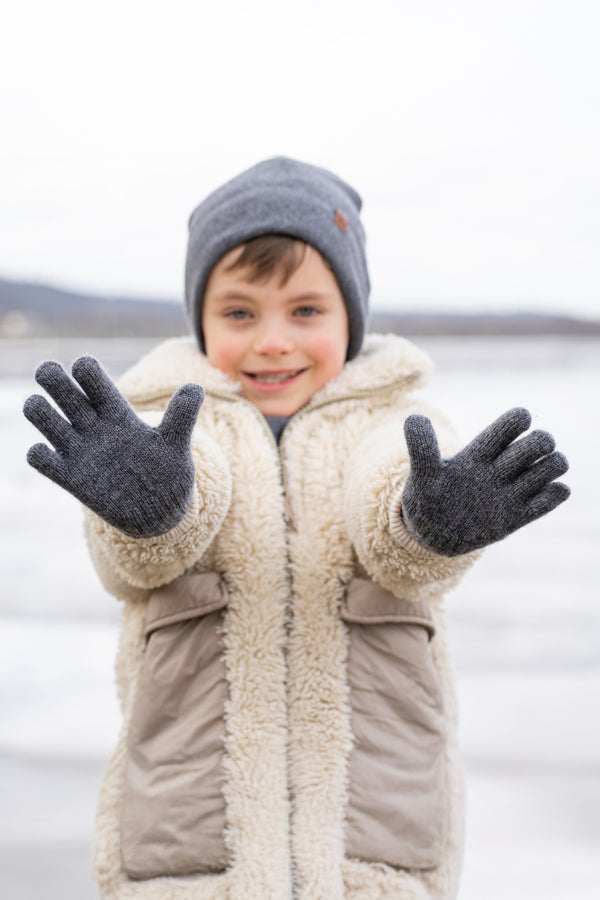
[341,578,447,869]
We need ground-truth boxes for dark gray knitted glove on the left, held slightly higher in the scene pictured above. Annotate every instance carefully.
[23,356,204,538]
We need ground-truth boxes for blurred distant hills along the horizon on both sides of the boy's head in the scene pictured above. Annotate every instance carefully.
[0,279,600,338]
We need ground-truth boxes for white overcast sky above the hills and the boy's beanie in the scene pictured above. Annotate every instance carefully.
[0,0,600,316]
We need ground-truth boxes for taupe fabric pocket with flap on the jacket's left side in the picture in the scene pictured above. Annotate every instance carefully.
[121,573,228,879]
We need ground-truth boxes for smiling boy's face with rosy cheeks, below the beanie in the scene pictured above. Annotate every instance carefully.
[202,246,348,416]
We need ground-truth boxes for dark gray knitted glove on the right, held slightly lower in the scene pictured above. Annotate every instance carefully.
[402,408,571,556]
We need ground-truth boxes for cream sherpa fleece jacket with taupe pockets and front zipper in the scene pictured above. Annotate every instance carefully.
[86,335,474,900]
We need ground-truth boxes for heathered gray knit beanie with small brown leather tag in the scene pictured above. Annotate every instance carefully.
[185,156,370,359]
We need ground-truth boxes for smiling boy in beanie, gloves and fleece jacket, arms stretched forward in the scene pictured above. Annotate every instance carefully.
[25,158,568,900]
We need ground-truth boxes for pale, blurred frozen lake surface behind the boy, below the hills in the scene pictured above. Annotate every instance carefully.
[0,339,600,900]
